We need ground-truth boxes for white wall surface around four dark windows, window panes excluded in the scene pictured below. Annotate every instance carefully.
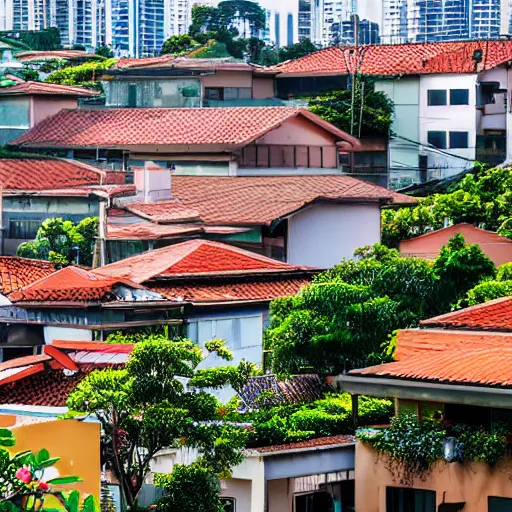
[419,74,479,177]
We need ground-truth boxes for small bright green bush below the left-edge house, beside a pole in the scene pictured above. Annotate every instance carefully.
[17,217,98,267]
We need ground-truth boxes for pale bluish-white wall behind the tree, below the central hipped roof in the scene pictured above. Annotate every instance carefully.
[187,310,265,368]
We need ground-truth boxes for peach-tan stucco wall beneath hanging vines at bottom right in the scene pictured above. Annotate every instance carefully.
[355,442,512,512]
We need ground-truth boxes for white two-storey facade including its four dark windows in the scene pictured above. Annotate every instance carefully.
[419,74,480,177]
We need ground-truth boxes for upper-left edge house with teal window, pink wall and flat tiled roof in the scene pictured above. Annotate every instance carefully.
[0,81,99,146]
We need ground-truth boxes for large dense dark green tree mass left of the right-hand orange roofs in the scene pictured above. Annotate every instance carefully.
[265,235,496,374]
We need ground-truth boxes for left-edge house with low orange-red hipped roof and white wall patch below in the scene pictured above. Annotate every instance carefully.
[0,267,184,353]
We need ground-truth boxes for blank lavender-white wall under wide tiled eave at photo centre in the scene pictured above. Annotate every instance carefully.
[287,204,380,268]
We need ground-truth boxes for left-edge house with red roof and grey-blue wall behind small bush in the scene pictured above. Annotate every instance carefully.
[0,155,136,255]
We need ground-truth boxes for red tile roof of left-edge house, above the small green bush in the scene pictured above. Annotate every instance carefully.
[0,158,110,190]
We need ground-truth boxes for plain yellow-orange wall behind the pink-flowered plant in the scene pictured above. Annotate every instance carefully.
[12,420,101,502]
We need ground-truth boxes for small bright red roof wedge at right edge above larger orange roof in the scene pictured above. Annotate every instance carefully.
[420,297,512,332]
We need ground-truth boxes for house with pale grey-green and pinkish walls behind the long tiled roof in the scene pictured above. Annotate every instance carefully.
[101,55,278,107]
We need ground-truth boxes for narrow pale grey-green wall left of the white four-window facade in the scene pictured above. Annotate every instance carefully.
[375,76,420,188]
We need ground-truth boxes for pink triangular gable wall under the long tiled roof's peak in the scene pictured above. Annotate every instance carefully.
[256,117,335,146]
